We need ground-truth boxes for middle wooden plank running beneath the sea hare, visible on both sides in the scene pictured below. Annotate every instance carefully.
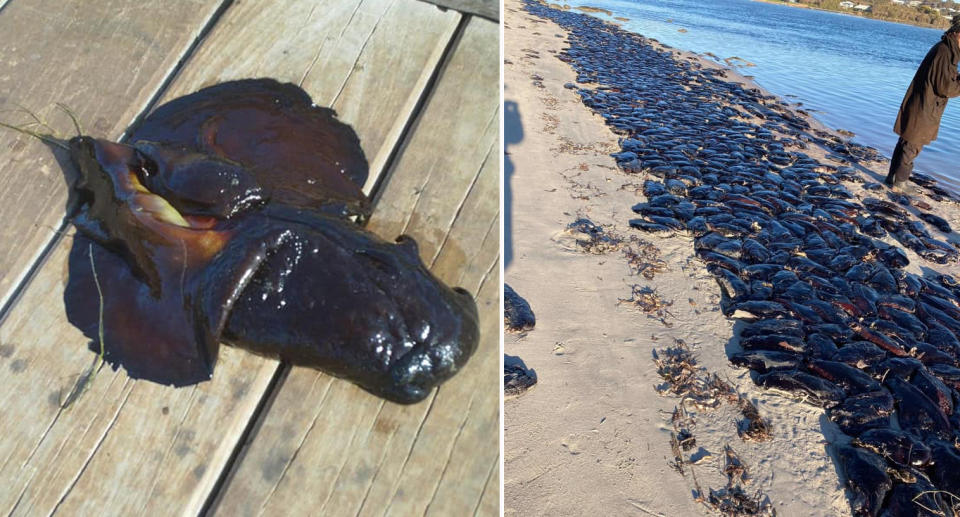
[0,0,468,515]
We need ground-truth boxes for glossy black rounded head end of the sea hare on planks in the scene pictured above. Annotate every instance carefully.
[221,209,479,403]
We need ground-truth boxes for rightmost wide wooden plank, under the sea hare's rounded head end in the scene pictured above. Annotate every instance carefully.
[215,15,500,515]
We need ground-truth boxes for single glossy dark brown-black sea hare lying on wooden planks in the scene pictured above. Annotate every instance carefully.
[65,79,479,403]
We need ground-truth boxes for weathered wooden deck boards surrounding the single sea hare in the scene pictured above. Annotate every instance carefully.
[0,0,501,516]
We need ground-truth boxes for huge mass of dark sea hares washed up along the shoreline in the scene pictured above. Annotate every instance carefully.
[527,2,960,515]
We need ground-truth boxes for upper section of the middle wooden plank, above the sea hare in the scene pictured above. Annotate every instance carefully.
[148,0,460,189]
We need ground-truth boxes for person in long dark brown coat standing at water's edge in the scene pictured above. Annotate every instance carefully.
[884,15,960,192]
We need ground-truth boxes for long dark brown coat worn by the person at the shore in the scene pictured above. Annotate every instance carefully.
[893,34,960,145]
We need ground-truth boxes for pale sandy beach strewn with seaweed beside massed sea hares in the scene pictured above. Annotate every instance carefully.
[504,0,960,516]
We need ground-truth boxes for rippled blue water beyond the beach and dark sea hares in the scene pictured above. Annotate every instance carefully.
[566,0,960,190]
